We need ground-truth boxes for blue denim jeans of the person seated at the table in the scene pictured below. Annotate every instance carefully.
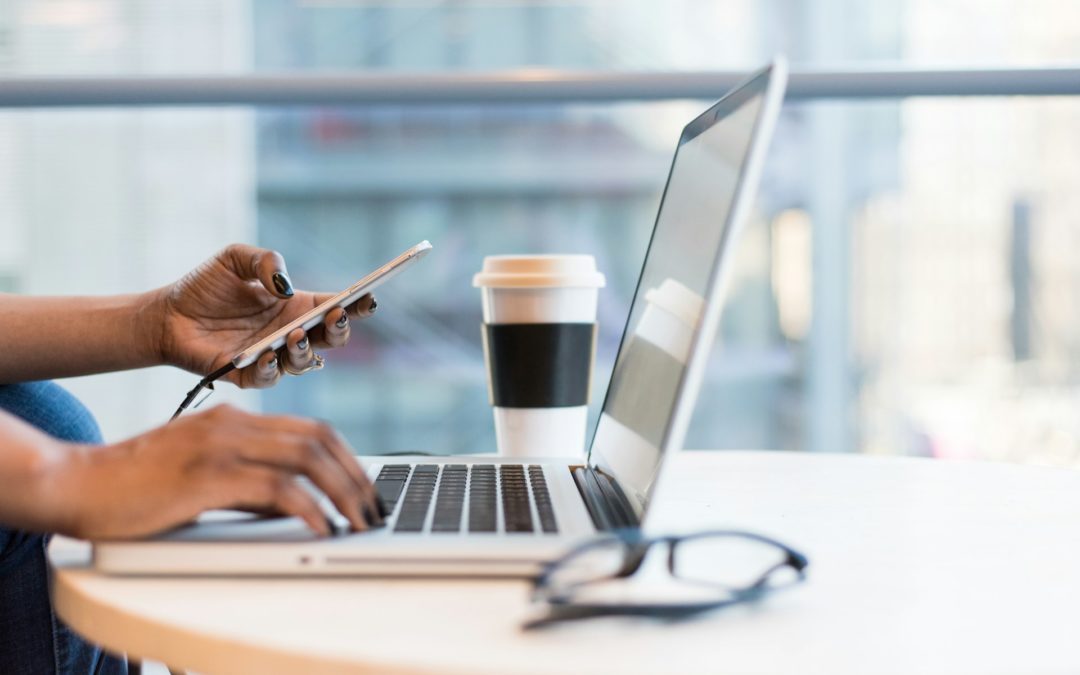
[0,382,127,675]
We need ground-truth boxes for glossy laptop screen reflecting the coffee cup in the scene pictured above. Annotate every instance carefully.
[589,64,770,516]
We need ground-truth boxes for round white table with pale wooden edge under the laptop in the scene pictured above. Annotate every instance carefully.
[52,451,1080,673]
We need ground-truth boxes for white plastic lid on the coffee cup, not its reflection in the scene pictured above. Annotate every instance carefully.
[473,255,605,288]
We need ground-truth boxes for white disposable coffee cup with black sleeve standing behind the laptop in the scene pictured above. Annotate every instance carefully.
[473,255,605,457]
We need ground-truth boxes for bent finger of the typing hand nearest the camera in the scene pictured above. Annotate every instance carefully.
[221,464,333,537]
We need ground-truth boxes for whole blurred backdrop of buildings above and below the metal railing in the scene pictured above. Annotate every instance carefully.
[0,0,1080,463]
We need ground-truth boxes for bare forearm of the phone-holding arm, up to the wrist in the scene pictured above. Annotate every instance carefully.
[0,292,162,383]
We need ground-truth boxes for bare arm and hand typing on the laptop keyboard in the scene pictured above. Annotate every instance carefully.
[0,406,382,539]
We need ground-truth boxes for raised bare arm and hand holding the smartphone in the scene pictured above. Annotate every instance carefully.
[0,244,376,387]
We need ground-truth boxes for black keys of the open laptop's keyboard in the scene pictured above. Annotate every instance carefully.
[375,464,558,534]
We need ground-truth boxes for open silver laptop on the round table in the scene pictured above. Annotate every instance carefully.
[94,59,787,577]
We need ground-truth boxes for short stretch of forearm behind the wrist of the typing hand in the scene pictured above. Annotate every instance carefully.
[0,411,81,534]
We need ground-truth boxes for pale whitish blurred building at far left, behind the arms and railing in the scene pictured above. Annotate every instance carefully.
[0,0,257,440]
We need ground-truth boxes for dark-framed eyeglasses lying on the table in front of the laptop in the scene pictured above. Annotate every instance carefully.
[523,528,810,630]
